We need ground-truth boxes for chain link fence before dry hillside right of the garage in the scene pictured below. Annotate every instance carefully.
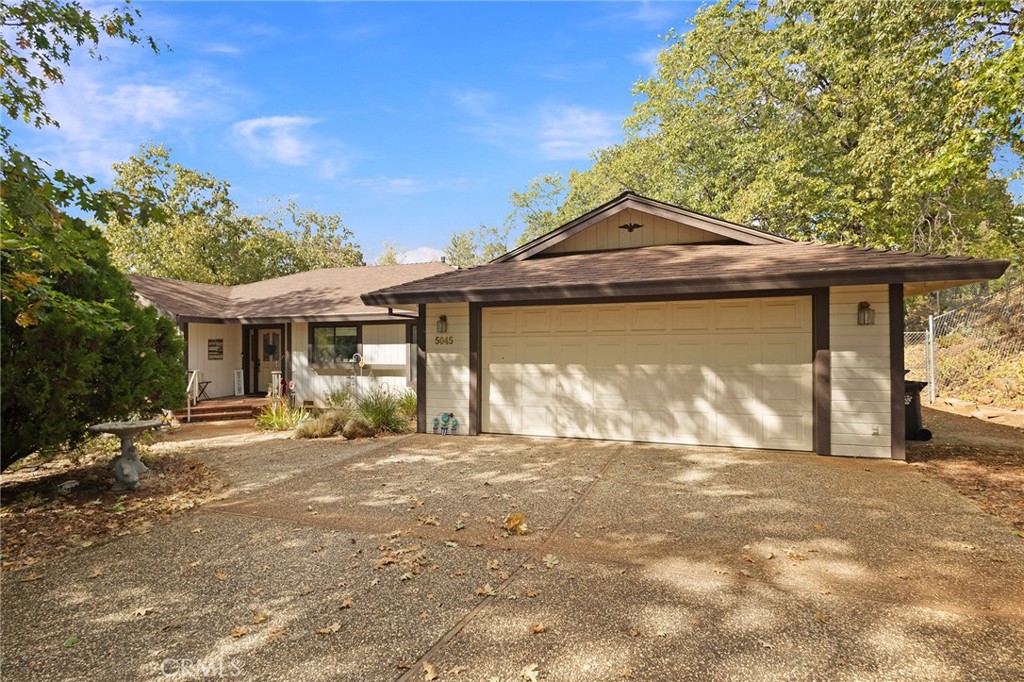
[904,286,1024,409]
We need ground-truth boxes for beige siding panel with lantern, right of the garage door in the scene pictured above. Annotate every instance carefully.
[829,286,892,458]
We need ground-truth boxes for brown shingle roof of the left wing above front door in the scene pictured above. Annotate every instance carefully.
[128,262,453,322]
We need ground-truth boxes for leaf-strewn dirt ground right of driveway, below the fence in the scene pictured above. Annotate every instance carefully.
[906,408,1024,537]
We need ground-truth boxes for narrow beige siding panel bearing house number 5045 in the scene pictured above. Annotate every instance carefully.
[425,303,469,433]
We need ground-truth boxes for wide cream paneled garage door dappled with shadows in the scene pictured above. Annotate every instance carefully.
[481,297,812,451]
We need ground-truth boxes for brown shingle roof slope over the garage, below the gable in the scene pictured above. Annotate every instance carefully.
[362,243,1009,305]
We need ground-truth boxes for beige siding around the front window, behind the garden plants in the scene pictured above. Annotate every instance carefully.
[292,323,409,407]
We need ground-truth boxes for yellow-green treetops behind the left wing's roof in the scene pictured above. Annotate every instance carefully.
[105,145,362,285]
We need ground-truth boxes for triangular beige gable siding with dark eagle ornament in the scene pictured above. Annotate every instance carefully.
[545,212,722,253]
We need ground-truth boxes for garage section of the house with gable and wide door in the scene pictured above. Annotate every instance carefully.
[362,193,1009,459]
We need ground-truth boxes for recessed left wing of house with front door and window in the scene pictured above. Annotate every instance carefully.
[129,262,453,404]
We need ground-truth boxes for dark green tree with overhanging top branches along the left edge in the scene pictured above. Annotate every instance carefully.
[0,0,184,468]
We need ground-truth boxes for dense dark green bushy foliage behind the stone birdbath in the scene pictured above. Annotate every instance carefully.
[0,151,184,468]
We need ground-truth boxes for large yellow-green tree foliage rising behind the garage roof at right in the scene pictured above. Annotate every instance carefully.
[503,0,1024,261]
